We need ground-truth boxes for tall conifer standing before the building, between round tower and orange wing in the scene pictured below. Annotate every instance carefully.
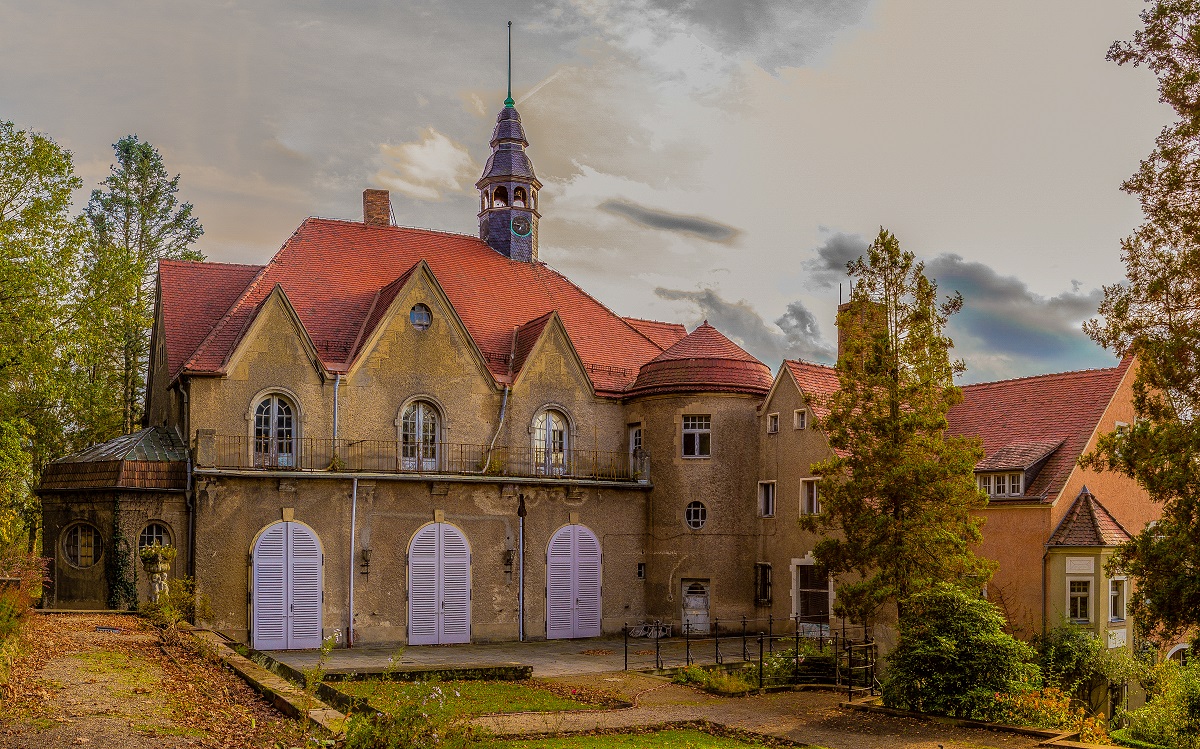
[802,229,992,623]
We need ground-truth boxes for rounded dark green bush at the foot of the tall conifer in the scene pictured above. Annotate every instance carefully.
[883,583,1038,720]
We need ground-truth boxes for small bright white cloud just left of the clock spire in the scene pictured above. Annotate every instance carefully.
[374,127,480,200]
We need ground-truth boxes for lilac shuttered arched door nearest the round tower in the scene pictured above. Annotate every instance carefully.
[546,525,601,640]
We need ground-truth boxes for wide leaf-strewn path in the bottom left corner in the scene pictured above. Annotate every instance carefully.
[0,613,305,749]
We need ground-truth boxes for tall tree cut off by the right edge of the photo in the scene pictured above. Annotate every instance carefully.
[1084,0,1200,641]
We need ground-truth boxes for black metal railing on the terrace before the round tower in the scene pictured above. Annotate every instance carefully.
[623,617,878,697]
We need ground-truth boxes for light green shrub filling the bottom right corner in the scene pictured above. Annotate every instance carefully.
[1124,660,1200,749]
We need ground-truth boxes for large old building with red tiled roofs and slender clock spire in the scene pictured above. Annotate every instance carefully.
[40,96,1171,662]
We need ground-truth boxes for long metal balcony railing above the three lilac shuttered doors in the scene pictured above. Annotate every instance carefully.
[196,432,650,484]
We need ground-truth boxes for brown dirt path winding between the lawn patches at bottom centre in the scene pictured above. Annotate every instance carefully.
[478,672,1039,749]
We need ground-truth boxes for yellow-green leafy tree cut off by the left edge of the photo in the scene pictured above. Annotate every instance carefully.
[0,121,84,546]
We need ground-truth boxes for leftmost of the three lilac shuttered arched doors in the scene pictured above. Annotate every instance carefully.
[250,521,323,651]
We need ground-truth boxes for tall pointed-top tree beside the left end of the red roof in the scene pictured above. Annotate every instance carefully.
[83,136,204,438]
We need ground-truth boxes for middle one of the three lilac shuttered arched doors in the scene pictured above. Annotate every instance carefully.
[408,522,470,645]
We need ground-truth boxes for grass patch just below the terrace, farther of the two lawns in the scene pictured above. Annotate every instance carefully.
[330,679,600,720]
